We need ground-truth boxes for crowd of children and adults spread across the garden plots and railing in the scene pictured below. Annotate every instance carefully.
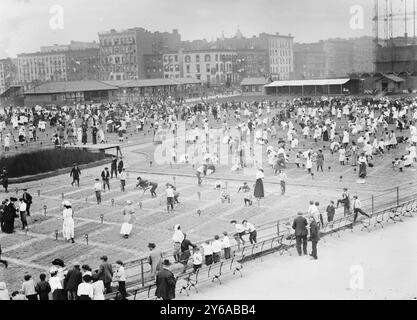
[0,92,417,300]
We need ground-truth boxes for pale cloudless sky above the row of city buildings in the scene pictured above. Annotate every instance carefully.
[0,0,400,58]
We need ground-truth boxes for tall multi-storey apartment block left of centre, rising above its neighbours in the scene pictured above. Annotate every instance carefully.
[99,28,181,80]
